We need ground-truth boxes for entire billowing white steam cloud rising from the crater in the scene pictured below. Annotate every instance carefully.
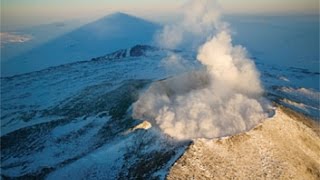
[133,0,269,139]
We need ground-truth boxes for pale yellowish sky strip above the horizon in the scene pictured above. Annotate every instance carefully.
[0,0,319,26]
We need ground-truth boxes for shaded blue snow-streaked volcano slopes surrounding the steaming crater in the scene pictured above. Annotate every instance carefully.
[1,45,319,179]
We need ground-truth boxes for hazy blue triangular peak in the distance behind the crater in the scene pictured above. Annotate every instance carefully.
[1,13,160,76]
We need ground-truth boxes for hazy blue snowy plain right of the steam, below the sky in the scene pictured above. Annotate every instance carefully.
[226,14,320,74]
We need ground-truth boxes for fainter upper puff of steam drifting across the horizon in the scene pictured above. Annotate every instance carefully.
[155,0,227,49]
